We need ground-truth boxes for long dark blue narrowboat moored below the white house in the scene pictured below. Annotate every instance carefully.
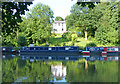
[19,46,79,56]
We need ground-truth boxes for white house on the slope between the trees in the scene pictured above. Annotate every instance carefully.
[51,21,66,34]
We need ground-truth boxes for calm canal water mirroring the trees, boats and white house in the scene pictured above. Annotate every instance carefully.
[2,53,119,84]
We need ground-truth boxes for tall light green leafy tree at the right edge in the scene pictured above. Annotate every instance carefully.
[95,2,119,44]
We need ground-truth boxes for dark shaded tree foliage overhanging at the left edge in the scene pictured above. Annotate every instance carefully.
[2,2,32,46]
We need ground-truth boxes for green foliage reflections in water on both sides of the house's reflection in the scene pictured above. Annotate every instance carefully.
[2,57,118,83]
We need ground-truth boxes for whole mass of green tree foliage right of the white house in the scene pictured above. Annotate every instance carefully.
[65,2,119,45]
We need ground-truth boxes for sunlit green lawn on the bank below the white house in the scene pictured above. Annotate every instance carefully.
[40,34,115,49]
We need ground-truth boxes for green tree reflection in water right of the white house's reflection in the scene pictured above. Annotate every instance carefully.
[66,61,118,82]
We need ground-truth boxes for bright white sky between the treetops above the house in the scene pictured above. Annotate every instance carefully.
[25,0,77,19]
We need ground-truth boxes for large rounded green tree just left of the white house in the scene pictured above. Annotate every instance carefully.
[20,3,53,45]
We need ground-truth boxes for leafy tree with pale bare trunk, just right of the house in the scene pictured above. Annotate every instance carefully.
[66,4,91,40]
